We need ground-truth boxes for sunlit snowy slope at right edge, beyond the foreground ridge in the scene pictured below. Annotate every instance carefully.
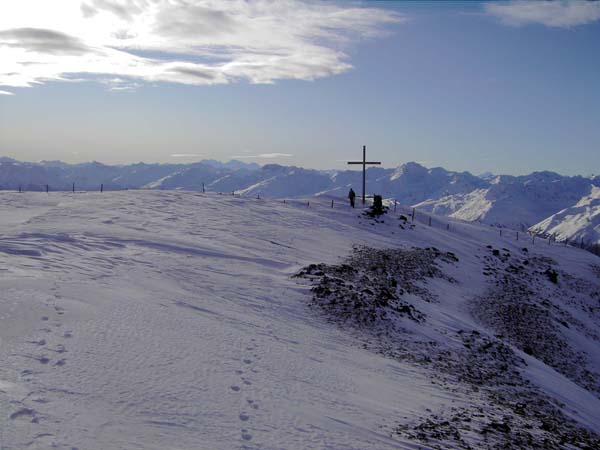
[531,186,600,244]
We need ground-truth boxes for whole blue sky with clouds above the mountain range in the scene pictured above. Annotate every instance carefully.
[0,0,600,175]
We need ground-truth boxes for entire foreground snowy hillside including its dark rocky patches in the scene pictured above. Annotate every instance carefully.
[0,191,600,450]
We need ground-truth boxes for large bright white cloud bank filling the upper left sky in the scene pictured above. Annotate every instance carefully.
[0,0,406,90]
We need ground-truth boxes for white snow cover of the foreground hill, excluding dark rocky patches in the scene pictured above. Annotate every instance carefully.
[0,190,600,450]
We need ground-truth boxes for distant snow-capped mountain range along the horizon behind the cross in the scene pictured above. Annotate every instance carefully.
[0,157,600,242]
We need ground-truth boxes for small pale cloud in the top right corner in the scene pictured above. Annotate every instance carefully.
[485,0,600,27]
